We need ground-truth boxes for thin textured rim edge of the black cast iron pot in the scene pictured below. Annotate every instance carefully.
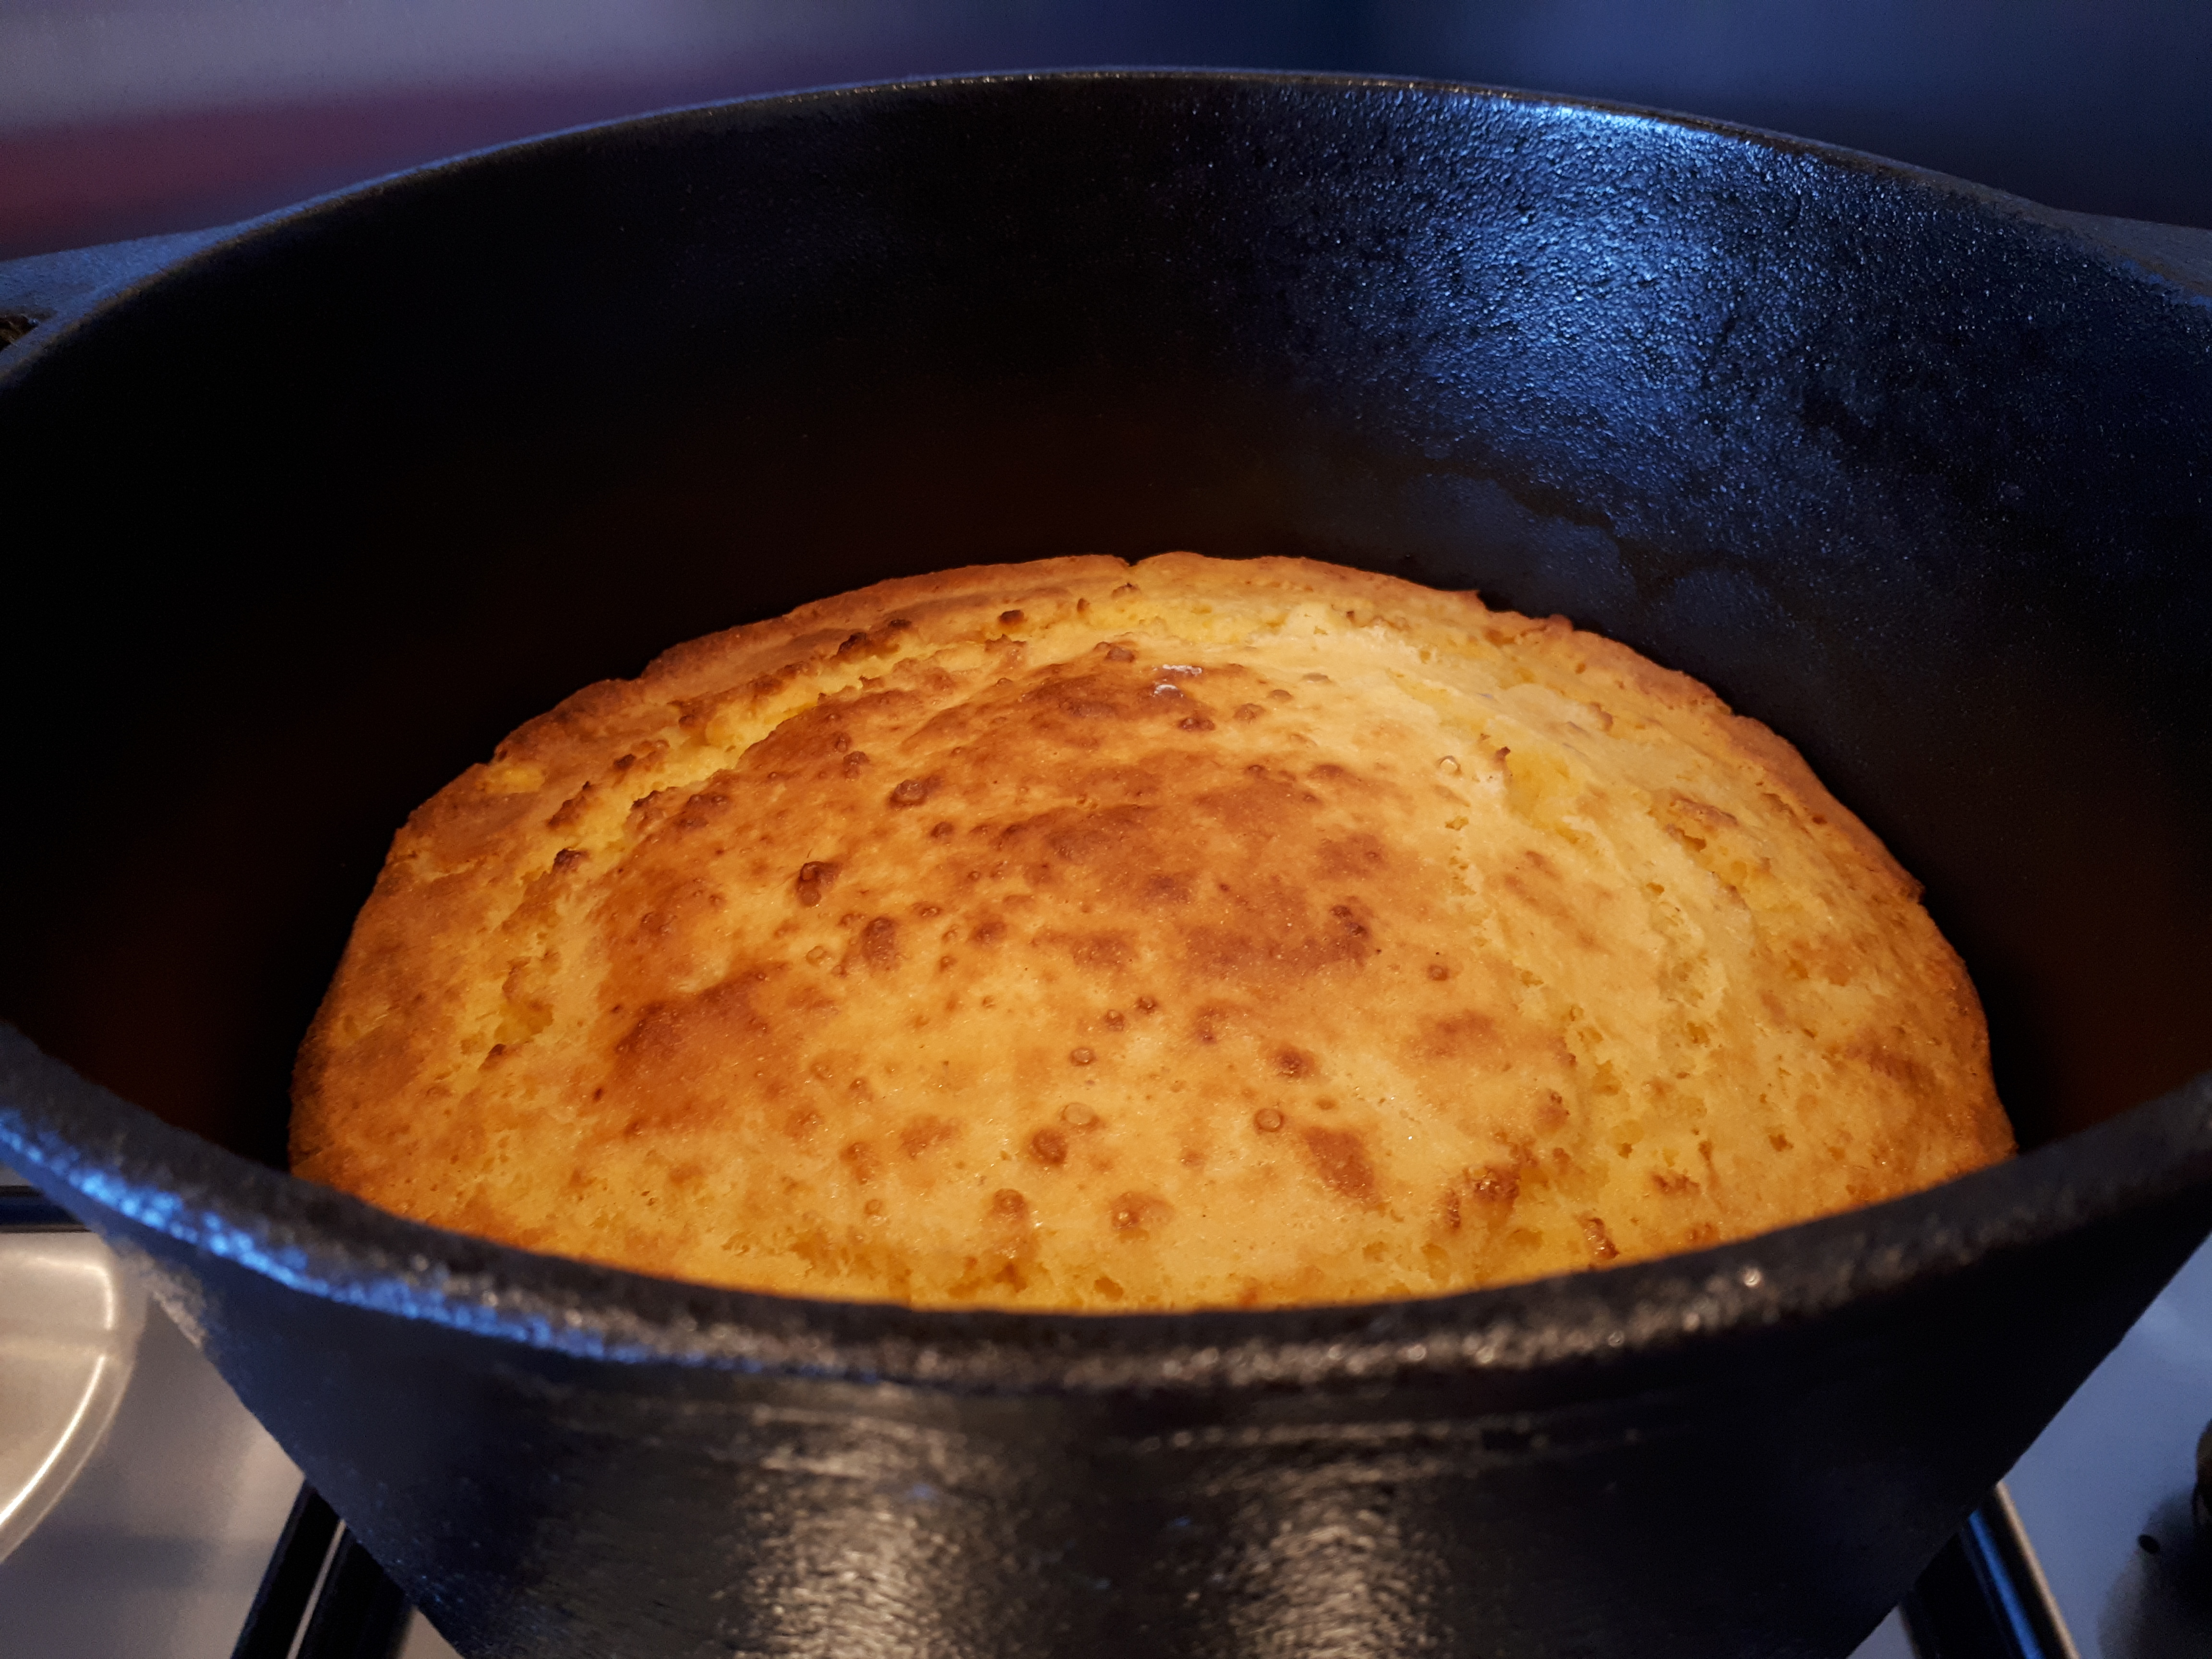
[0,69,2212,1394]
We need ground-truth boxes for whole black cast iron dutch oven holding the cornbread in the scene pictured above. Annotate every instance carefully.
[0,73,2212,1659]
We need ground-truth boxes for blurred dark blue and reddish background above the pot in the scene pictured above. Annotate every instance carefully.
[0,0,2212,257]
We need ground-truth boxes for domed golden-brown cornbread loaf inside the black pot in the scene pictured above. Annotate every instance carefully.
[292,553,2011,1310]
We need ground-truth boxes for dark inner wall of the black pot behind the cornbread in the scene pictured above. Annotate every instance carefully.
[0,77,2212,1161]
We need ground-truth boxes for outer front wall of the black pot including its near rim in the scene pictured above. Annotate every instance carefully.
[13,1042,2212,1659]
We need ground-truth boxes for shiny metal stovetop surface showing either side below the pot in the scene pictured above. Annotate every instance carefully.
[0,1221,2212,1659]
